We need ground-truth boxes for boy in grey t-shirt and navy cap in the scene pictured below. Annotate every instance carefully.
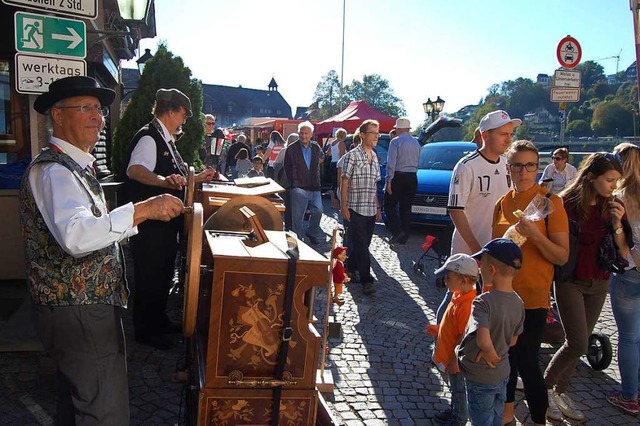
[457,238,524,426]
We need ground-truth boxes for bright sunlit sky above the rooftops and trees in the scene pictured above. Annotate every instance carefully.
[124,0,635,127]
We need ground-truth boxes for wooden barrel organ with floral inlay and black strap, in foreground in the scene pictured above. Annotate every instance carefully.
[184,203,330,426]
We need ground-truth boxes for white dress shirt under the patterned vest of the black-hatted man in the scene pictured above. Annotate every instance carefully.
[29,137,138,257]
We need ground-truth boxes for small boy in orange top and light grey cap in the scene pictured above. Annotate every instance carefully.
[425,253,478,425]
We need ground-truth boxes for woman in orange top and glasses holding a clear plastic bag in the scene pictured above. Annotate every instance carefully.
[493,140,569,425]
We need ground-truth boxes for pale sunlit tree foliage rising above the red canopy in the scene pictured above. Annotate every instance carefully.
[309,70,406,120]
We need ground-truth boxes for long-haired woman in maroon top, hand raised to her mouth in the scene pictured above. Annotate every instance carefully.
[544,152,629,420]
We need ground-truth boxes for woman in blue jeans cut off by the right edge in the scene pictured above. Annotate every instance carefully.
[607,142,640,415]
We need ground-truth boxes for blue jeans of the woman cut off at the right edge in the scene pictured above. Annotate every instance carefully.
[611,269,640,399]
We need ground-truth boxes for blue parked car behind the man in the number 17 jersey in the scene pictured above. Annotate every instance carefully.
[411,142,478,226]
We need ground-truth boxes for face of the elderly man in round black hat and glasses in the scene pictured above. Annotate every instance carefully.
[51,96,104,152]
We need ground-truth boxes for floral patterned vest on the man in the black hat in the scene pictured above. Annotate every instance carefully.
[20,148,129,307]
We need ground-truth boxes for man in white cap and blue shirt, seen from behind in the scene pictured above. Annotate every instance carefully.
[384,118,420,244]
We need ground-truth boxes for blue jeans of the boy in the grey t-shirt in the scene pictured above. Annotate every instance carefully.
[466,377,509,426]
